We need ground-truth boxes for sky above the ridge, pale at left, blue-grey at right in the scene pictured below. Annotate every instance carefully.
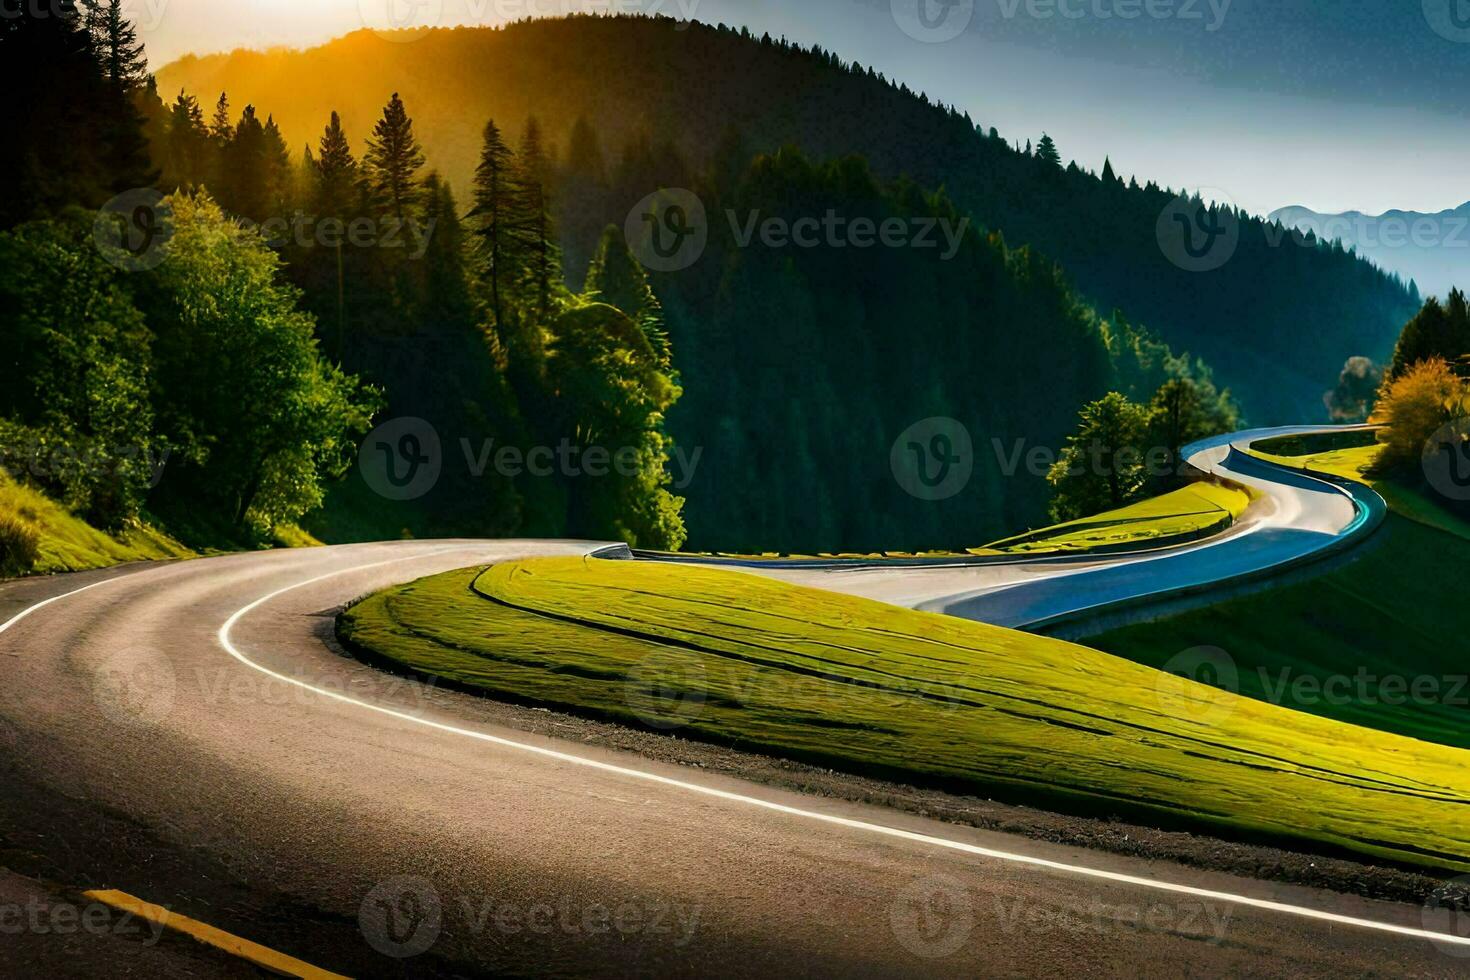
[125,0,1470,215]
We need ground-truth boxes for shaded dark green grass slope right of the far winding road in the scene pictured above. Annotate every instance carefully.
[1083,442,1470,748]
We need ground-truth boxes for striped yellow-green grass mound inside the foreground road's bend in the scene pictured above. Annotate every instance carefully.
[338,558,1470,870]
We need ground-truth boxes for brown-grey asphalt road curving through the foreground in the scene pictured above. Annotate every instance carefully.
[0,541,1470,976]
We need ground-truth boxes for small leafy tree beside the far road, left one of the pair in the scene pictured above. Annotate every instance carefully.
[1047,391,1148,520]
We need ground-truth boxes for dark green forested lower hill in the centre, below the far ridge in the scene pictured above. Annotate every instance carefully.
[596,148,1216,551]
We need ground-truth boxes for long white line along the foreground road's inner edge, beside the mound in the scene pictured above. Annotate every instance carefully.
[219,548,1470,946]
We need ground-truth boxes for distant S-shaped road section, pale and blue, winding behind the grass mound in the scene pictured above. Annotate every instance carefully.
[729,426,1386,629]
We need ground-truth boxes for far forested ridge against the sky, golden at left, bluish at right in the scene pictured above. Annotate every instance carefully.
[159,16,1419,423]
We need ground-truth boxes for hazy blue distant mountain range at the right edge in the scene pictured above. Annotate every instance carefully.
[1270,201,1470,297]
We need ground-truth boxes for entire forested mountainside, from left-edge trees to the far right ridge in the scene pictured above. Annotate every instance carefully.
[0,9,1381,551]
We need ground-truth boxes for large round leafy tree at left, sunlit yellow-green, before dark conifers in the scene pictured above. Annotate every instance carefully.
[140,194,378,532]
